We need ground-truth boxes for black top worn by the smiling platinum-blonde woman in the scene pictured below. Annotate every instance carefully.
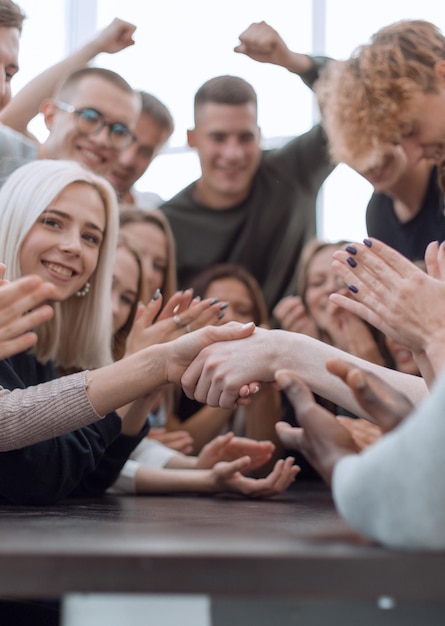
[0,352,148,504]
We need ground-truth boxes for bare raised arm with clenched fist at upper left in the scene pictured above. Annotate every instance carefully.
[0,18,136,135]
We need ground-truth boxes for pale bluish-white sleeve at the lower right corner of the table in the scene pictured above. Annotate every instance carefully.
[332,373,445,549]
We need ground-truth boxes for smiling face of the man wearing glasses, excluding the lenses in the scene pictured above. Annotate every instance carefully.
[41,76,140,175]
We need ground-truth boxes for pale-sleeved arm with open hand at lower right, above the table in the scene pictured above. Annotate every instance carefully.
[276,371,445,550]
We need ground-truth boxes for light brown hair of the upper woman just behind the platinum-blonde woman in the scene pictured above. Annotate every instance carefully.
[120,209,177,304]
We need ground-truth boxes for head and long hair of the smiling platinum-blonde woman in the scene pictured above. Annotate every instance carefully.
[0,160,118,368]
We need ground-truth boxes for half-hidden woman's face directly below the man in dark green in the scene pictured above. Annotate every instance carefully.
[204,276,255,324]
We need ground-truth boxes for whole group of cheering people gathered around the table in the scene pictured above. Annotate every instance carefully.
[0,0,445,580]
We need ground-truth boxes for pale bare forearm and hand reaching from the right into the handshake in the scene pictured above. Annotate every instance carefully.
[181,328,427,419]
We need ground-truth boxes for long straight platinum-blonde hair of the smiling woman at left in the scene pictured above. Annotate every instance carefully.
[0,160,118,369]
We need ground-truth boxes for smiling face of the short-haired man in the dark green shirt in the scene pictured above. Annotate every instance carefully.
[188,102,261,208]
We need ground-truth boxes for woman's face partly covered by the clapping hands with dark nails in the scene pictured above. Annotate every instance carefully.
[305,246,346,329]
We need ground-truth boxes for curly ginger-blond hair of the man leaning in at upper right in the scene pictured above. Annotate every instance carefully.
[315,20,445,171]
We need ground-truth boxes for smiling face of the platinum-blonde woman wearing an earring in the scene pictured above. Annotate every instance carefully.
[20,182,106,301]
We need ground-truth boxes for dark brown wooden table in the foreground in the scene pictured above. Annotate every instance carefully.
[0,483,445,626]
